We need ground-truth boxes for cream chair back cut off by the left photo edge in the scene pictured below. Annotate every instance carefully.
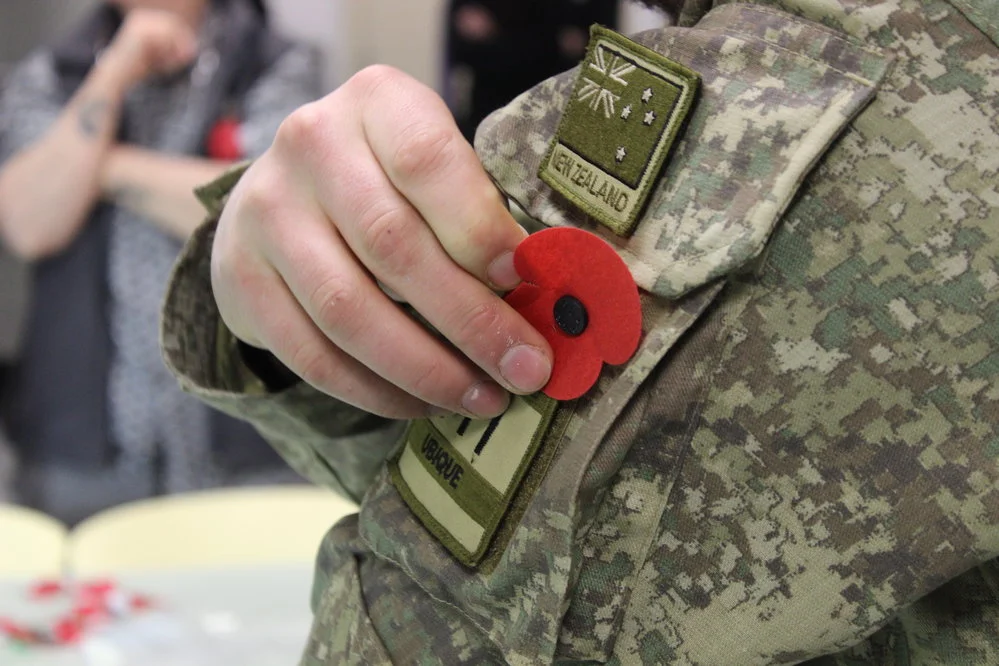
[0,504,66,578]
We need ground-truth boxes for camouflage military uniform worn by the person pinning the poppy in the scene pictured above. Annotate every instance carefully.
[163,0,999,666]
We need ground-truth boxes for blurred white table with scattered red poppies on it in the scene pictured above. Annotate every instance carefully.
[0,566,312,666]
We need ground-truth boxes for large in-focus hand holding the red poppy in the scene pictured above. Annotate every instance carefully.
[212,66,551,418]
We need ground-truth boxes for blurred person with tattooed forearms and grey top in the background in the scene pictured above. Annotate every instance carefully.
[0,0,319,522]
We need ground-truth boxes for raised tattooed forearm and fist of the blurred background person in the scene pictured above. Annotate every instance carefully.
[0,9,196,259]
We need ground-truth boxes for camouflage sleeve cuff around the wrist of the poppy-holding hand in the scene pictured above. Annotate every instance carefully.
[161,165,404,501]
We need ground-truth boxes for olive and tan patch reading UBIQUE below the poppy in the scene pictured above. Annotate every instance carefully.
[389,393,564,567]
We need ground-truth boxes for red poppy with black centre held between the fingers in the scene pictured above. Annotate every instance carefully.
[506,227,642,400]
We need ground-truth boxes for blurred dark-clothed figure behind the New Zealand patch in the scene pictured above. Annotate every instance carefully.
[446,0,618,141]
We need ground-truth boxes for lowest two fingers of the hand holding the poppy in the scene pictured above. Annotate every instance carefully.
[218,156,508,417]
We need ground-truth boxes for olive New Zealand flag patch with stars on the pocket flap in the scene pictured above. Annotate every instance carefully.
[538,25,700,236]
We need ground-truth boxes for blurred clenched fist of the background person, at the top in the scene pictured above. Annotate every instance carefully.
[103,9,198,88]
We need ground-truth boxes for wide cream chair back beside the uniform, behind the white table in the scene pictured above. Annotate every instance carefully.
[67,486,357,577]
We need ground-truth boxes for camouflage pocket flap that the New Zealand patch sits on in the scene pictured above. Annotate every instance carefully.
[476,4,888,299]
